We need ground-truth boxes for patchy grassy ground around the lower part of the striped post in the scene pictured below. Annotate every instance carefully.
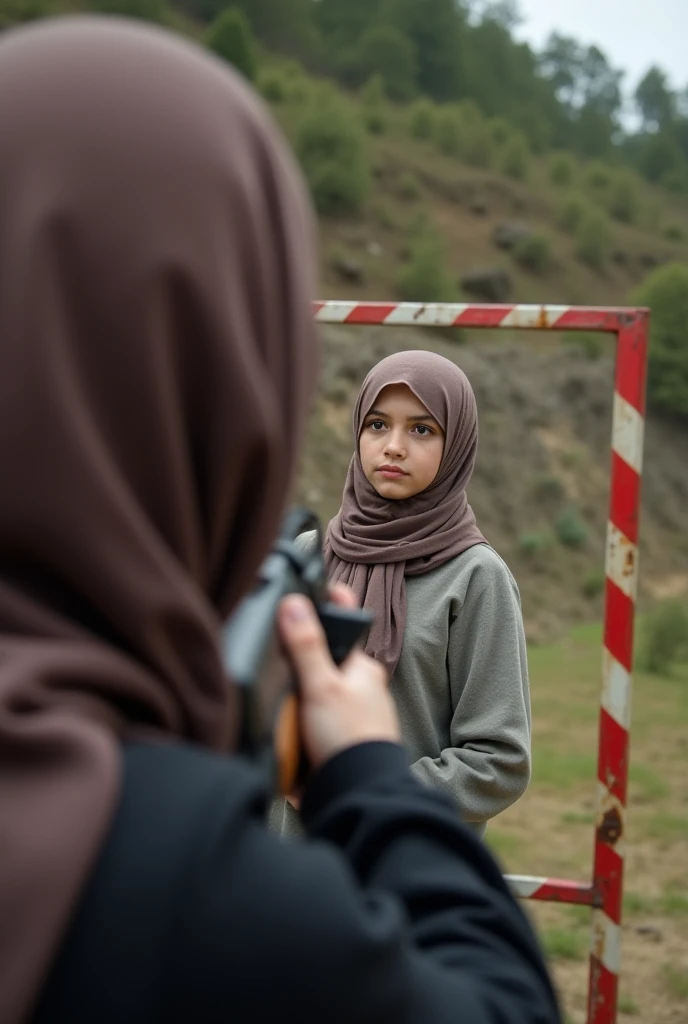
[488,627,688,1024]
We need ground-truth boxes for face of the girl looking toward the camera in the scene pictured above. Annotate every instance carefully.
[358,384,444,501]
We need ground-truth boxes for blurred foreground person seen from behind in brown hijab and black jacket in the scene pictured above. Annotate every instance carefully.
[0,18,558,1024]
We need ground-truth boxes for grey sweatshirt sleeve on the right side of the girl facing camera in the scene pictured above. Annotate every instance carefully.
[413,551,530,823]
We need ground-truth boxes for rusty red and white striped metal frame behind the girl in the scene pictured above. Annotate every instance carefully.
[314,301,649,1024]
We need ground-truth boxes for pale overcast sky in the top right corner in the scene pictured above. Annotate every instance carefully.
[517,0,688,94]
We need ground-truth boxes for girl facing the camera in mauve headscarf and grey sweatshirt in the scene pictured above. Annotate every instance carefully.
[272,351,530,836]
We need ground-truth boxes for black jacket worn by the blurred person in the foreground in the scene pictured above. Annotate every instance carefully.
[34,743,559,1024]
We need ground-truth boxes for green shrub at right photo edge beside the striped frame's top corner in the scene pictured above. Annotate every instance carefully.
[633,263,688,422]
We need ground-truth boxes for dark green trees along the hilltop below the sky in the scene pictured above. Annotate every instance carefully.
[8,0,688,190]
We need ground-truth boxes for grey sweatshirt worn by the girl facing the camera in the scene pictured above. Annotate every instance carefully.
[270,534,530,836]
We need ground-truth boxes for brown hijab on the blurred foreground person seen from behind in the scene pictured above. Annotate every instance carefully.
[0,17,316,1024]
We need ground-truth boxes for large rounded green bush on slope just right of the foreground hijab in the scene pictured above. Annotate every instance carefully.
[296,94,370,217]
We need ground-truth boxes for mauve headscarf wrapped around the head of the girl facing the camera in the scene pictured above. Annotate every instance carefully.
[326,351,485,676]
